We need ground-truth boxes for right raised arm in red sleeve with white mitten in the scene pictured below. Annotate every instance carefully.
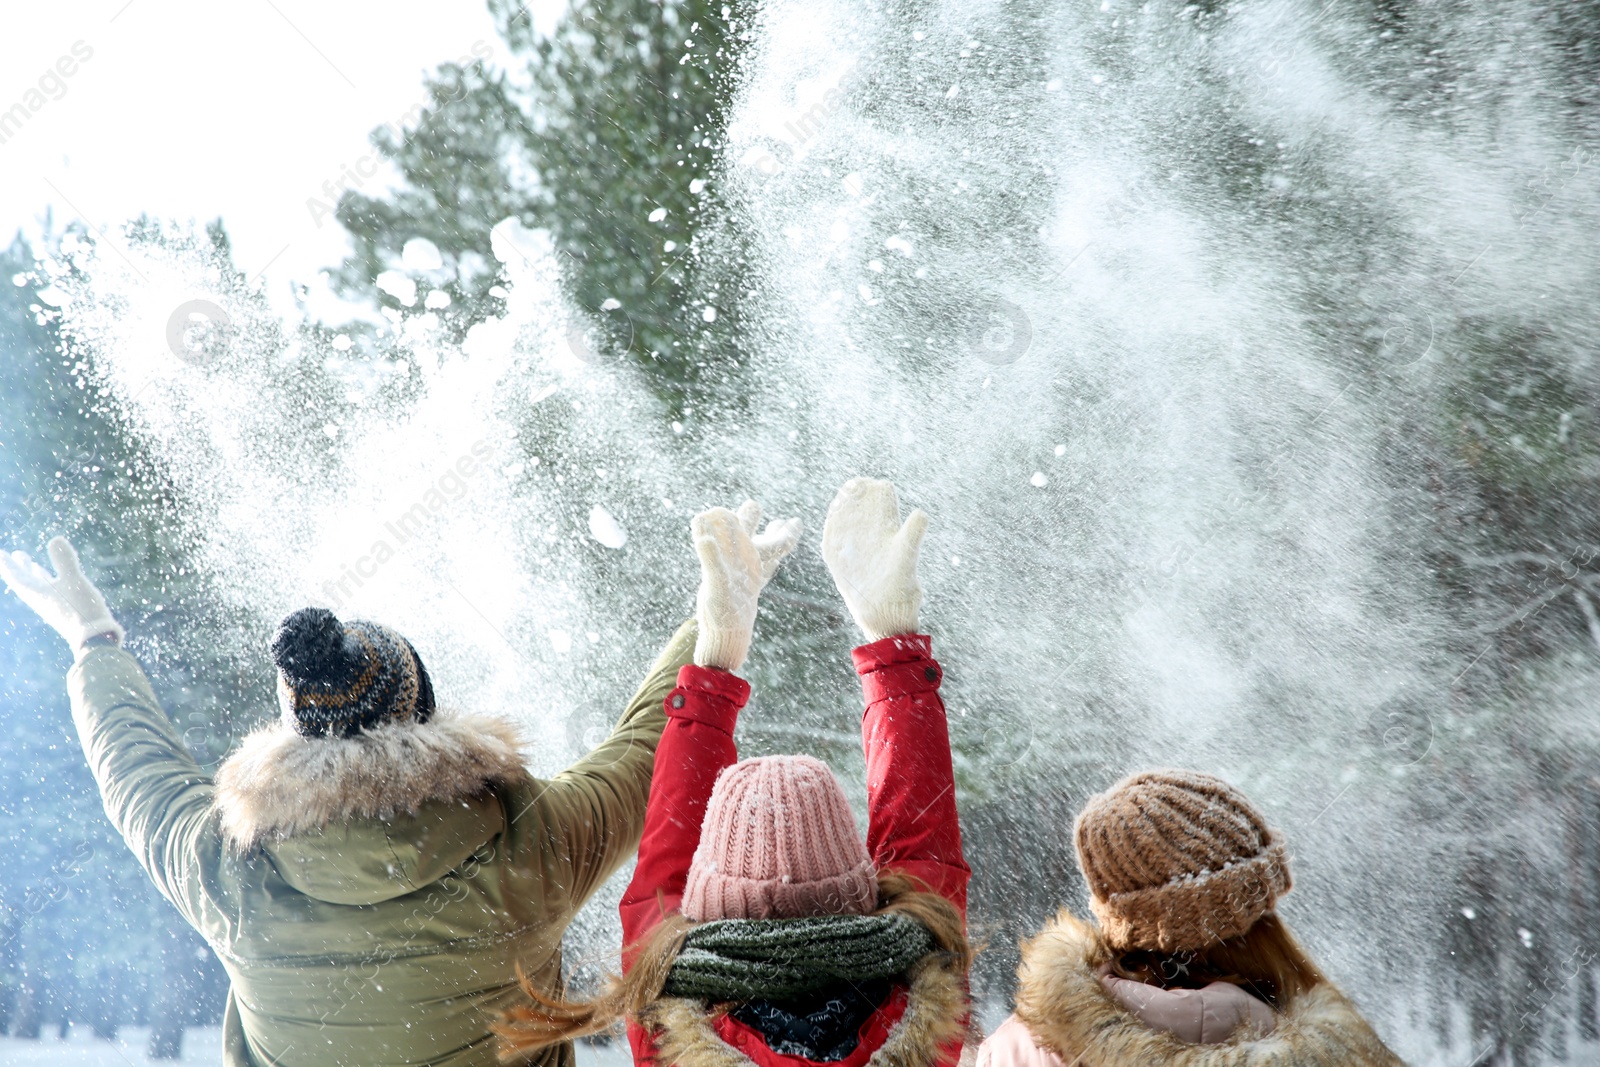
[822,478,971,915]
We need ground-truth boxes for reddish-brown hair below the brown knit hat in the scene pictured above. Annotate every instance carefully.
[1110,912,1326,1009]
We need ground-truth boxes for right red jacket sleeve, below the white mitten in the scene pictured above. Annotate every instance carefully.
[853,633,971,915]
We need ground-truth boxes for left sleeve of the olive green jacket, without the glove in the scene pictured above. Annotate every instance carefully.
[67,646,222,928]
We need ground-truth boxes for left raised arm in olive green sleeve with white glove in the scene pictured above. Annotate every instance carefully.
[0,537,222,923]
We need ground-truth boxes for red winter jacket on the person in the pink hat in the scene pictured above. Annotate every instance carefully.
[621,633,971,1067]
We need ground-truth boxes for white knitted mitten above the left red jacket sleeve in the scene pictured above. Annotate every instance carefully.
[690,501,800,670]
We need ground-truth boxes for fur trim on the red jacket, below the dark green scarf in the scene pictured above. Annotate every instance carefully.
[640,955,968,1067]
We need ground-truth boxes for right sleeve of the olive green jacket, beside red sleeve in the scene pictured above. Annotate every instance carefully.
[512,619,696,909]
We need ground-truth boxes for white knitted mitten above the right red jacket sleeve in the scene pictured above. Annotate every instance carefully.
[822,478,928,641]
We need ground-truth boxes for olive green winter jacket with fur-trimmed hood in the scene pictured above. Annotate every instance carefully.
[67,622,694,1067]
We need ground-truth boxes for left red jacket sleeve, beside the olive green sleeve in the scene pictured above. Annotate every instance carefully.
[618,664,750,1064]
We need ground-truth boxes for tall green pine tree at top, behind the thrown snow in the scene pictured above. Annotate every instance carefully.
[336,0,747,397]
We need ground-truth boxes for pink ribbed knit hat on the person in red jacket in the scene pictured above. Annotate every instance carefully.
[682,755,878,923]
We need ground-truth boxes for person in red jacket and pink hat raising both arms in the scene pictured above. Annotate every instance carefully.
[501,478,971,1067]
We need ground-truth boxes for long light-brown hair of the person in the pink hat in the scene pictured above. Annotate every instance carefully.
[493,872,973,1053]
